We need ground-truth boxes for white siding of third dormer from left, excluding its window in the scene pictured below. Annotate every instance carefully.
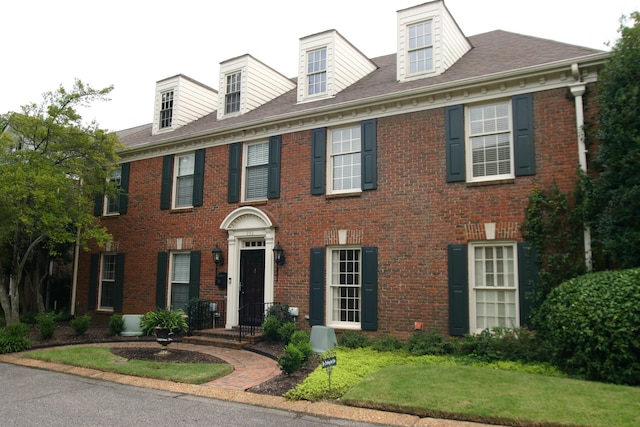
[298,30,376,102]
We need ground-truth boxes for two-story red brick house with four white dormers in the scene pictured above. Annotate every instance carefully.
[75,1,608,337]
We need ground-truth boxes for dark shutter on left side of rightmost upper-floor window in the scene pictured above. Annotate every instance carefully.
[444,105,465,182]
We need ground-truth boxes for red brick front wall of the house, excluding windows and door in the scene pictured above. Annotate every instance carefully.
[76,83,600,337]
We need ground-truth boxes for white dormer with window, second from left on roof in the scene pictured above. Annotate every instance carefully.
[218,55,296,119]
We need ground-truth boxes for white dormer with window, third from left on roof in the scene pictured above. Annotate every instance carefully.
[298,30,376,102]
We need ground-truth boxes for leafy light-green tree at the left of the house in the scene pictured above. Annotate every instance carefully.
[0,80,120,324]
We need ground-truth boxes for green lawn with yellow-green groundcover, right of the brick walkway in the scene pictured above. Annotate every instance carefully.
[288,349,640,427]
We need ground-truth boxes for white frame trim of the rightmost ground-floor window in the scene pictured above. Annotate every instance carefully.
[467,240,520,334]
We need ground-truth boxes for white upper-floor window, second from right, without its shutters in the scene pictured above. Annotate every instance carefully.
[328,125,362,193]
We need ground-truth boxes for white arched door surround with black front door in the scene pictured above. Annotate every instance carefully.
[220,206,277,329]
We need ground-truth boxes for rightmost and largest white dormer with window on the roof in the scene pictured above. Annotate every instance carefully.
[397,0,472,82]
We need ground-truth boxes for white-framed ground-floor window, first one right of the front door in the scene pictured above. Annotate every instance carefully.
[327,248,362,328]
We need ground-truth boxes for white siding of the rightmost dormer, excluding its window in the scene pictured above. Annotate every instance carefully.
[396,1,471,82]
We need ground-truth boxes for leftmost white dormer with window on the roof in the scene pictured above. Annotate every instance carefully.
[152,74,218,135]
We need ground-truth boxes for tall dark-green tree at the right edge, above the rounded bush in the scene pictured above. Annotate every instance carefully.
[590,12,640,268]
